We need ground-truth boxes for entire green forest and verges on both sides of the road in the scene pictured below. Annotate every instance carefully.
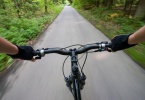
[0,0,145,71]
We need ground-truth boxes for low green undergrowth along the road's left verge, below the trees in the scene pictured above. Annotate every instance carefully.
[0,4,64,71]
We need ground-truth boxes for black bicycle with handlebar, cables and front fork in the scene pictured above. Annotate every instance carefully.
[34,42,111,100]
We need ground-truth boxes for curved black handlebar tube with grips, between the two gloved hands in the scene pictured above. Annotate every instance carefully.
[33,42,111,57]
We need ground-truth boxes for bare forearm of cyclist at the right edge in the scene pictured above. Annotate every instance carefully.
[128,26,145,44]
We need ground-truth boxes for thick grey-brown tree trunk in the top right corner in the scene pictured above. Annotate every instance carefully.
[134,0,145,19]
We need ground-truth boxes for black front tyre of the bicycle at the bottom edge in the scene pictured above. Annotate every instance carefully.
[73,79,82,100]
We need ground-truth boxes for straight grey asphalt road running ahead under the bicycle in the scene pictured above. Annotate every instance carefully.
[0,6,145,100]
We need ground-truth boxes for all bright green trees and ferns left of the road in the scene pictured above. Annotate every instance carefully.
[0,0,64,71]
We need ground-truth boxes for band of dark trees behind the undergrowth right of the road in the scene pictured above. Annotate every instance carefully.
[73,0,145,20]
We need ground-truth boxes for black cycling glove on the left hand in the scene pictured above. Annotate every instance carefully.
[8,46,34,60]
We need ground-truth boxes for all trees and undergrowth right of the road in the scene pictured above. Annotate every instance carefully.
[73,0,145,68]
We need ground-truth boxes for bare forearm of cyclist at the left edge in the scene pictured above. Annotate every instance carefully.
[0,37,18,55]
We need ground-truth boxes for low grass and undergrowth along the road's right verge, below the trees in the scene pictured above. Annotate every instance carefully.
[75,7,145,69]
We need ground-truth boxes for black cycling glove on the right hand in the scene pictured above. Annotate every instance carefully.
[111,34,136,51]
